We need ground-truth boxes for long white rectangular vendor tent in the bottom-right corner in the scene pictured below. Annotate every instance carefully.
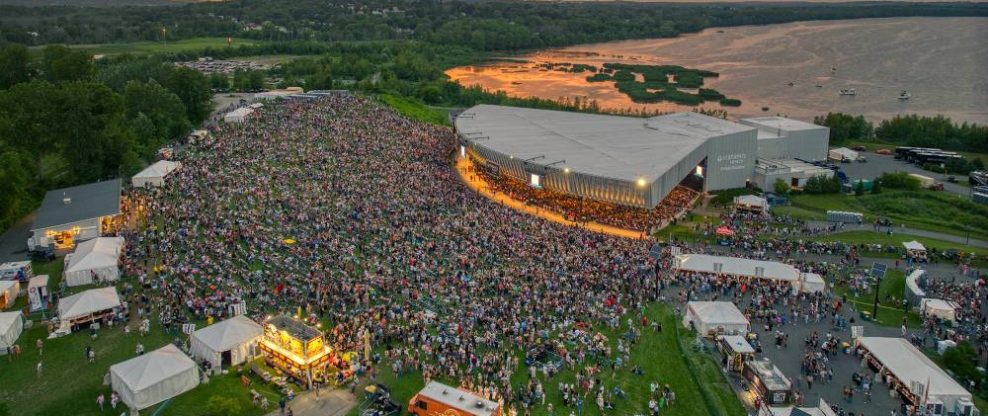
[858,337,972,414]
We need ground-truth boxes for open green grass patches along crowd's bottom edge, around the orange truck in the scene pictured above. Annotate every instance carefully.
[350,304,745,416]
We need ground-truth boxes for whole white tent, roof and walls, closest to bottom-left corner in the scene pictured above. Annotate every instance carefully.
[110,344,199,410]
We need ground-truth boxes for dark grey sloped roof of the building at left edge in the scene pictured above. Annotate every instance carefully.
[31,179,120,230]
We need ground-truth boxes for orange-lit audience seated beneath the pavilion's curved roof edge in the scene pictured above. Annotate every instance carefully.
[470,167,699,234]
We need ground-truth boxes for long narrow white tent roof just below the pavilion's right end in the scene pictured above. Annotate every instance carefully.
[672,254,800,283]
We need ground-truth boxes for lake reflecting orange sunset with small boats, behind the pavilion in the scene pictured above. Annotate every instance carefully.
[446,18,988,124]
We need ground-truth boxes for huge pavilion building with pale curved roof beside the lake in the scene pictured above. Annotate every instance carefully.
[454,105,832,209]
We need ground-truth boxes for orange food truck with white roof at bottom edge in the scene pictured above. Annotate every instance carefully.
[408,381,501,416]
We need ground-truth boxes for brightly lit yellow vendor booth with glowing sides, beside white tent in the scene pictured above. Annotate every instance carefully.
[258,316,331,388]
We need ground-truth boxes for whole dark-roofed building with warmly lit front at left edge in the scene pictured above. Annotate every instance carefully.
[27,179,120,250]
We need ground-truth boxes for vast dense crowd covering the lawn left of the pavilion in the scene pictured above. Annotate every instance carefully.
[119,98,708,413]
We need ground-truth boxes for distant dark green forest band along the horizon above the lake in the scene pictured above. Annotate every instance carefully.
[0,0,988,46]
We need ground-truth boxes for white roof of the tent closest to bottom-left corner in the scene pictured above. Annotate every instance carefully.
[110,344,196,391]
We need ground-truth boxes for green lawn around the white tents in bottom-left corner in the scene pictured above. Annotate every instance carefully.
[0,258,280,416]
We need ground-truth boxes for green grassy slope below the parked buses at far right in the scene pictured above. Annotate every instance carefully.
[773,190,988,239]
